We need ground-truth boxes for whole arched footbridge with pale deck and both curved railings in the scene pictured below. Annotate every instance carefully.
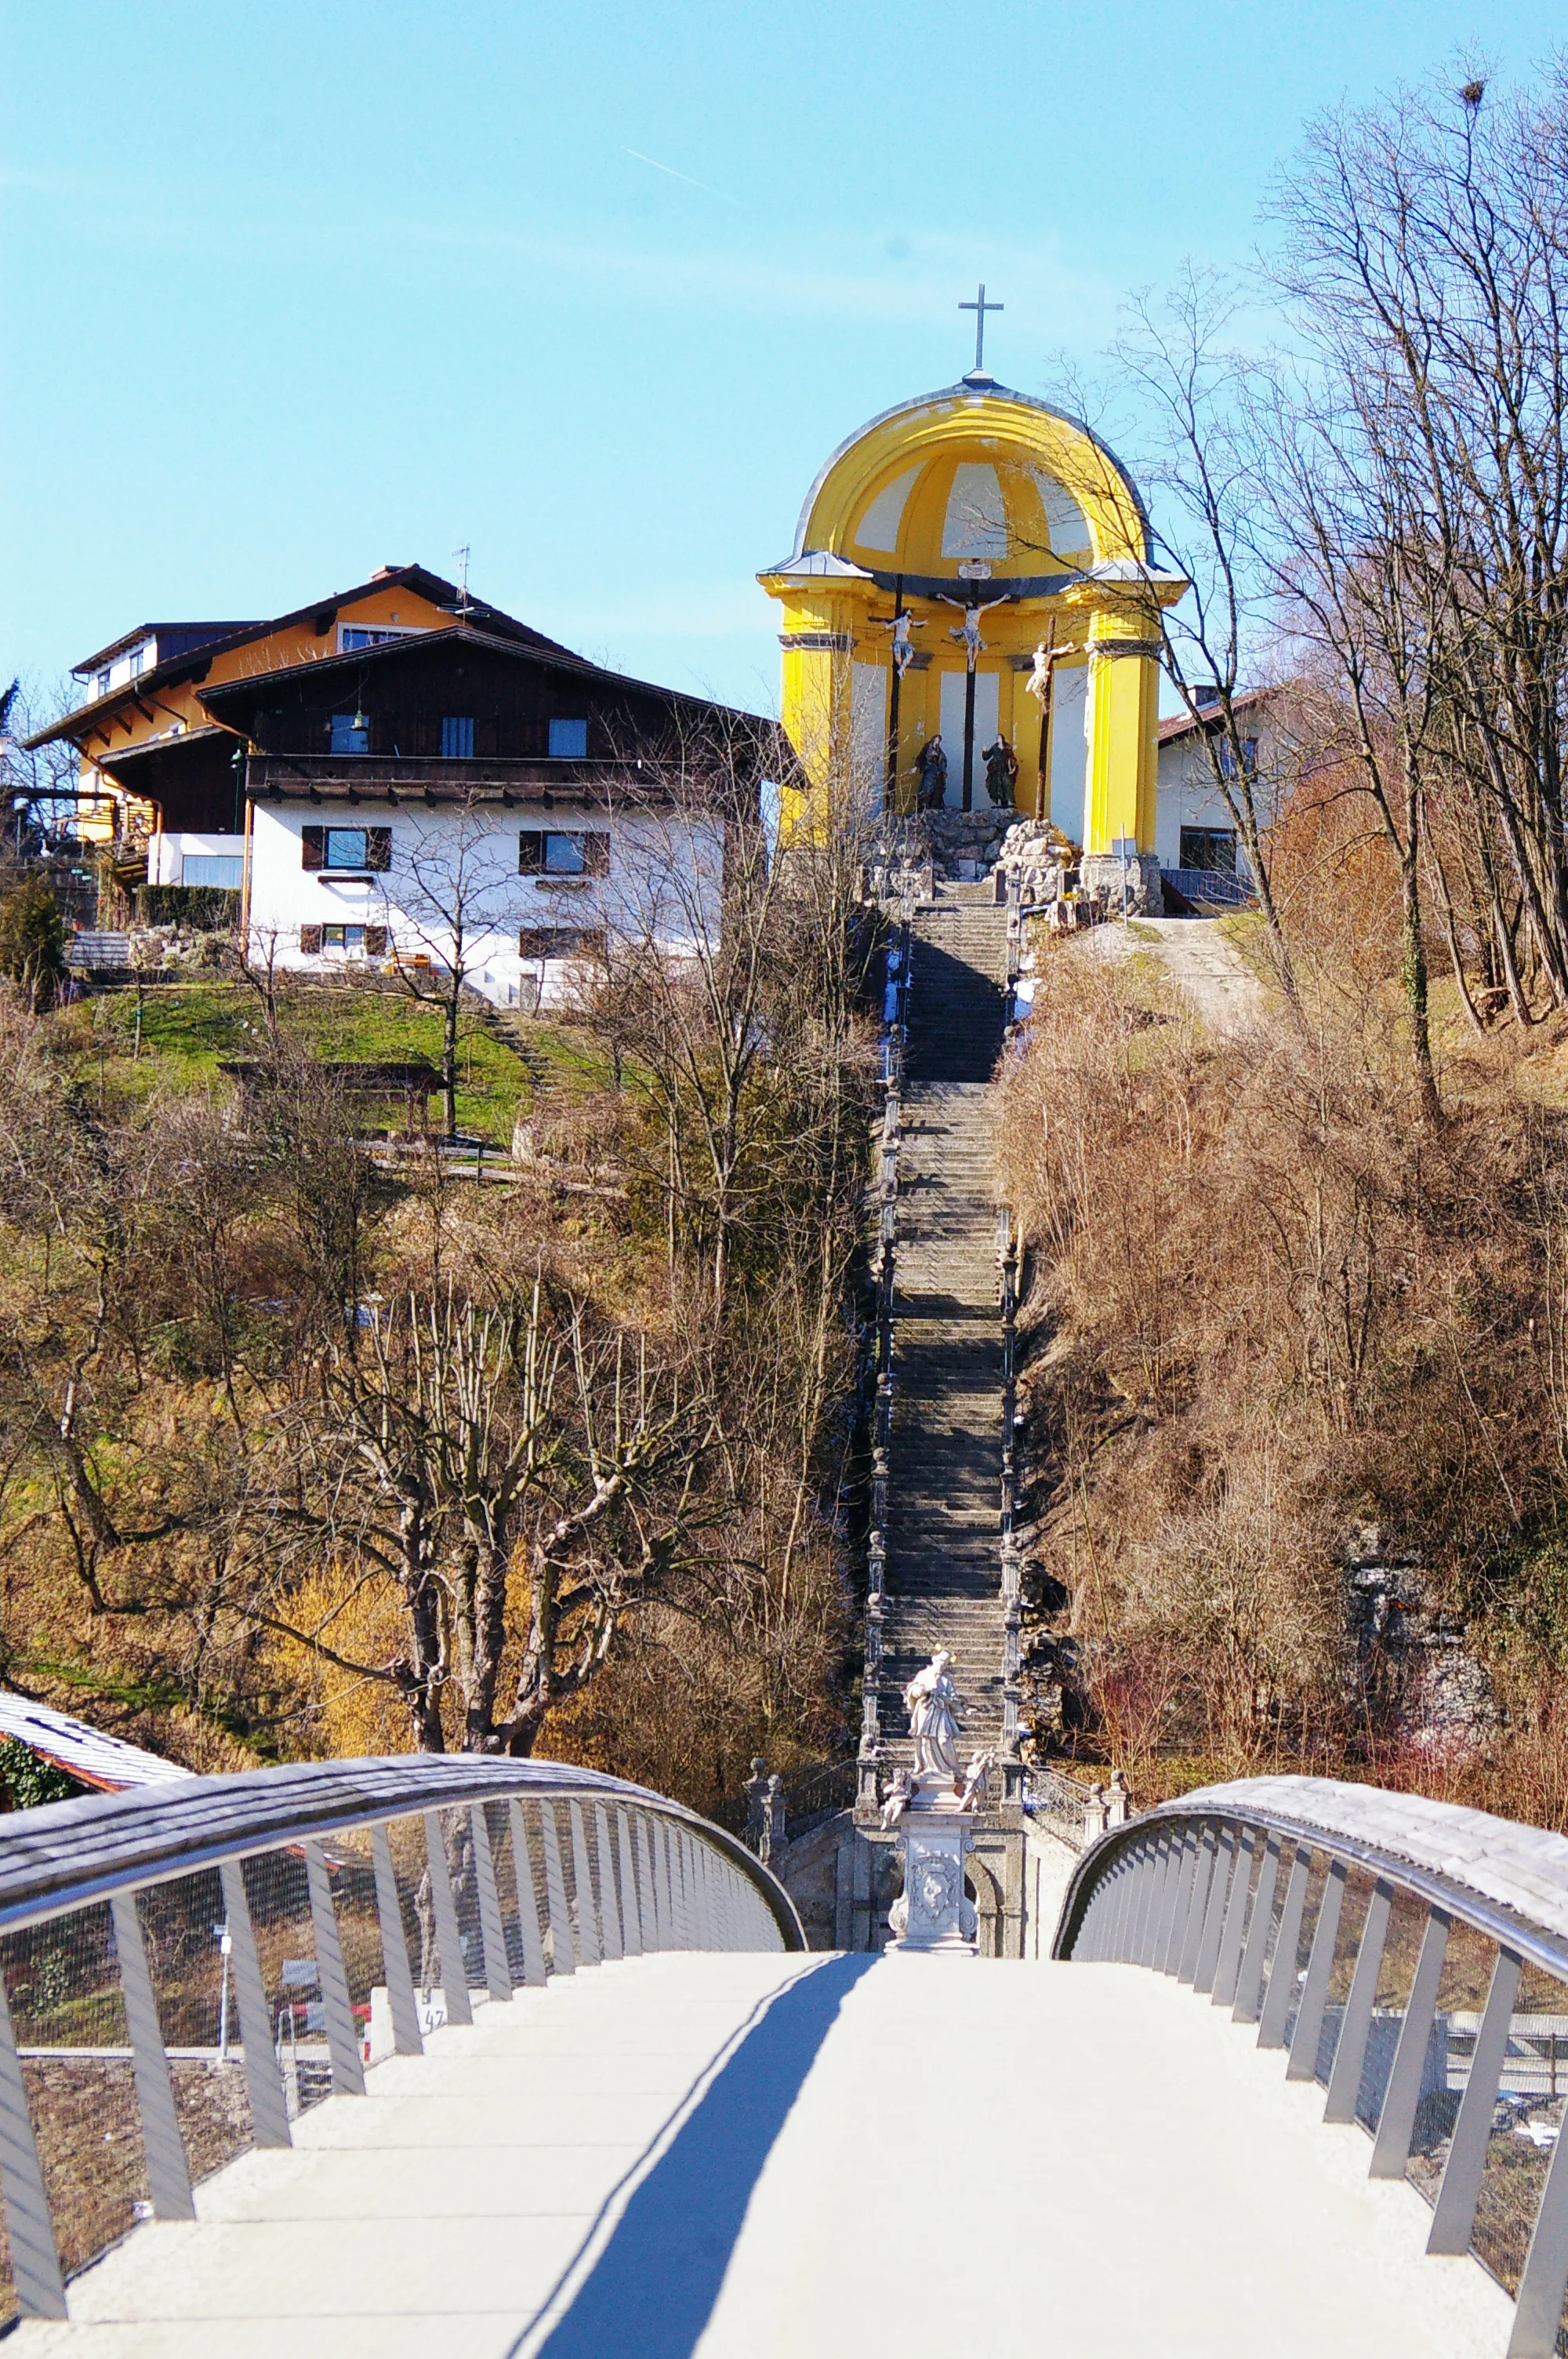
[0,1757,1568,2359]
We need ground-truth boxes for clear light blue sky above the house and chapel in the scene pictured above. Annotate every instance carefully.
[0,0,1568,710]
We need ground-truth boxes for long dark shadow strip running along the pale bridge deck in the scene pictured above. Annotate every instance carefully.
[517,1956,877,2359]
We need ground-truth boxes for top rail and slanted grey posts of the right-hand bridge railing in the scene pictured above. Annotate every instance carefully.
[1051,1776,1568,2359]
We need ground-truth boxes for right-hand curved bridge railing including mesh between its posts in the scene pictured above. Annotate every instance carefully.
[1054,1776,1568,2359]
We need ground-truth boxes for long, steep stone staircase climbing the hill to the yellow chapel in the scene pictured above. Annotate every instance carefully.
[880,882,1007,1762]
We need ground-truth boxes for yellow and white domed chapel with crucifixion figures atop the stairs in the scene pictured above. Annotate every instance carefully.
[757,309,1189,854]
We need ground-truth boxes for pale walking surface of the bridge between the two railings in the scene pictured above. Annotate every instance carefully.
[9,1956,1512,2359]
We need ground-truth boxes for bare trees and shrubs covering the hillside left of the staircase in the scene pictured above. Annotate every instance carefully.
[0,781,875,1807]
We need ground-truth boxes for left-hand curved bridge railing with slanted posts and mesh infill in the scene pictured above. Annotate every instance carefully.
[0,1755,807,2321]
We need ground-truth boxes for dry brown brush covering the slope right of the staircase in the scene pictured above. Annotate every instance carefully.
[1002,867,1568,1826]
